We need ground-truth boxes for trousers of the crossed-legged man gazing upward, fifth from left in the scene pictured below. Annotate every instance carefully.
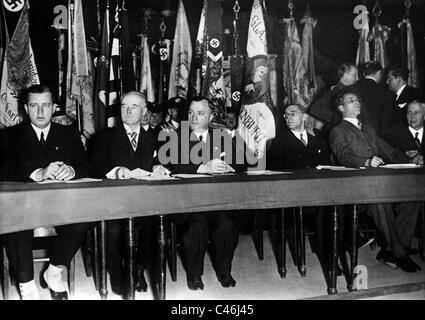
[368,202,421,258]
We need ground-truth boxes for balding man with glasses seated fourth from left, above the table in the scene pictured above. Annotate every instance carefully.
[267,104,330,170]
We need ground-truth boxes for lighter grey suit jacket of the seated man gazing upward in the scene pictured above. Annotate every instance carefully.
[329,120,410,167]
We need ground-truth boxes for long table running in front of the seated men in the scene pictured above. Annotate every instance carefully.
[0,168,425,298]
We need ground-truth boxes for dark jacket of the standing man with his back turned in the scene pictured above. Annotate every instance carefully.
[350,79,401,137]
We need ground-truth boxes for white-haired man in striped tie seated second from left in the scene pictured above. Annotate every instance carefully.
[90,91,165,294]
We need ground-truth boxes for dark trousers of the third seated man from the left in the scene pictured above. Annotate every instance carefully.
[175,213,239,276]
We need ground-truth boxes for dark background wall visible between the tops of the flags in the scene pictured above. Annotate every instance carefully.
[3,0,425,96]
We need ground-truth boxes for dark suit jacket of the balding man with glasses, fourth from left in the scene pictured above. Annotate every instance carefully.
[267,131,330,170]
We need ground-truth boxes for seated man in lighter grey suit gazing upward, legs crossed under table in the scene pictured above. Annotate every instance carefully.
[329,90,423,272]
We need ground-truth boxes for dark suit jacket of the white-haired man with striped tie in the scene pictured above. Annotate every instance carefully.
[90,124,157,178]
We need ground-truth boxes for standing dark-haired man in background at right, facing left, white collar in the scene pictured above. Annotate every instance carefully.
[386,65,422,122]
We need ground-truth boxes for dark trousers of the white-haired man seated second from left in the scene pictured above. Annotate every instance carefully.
[106,217,155,285]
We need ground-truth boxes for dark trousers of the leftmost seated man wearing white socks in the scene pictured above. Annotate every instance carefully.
[4,223,91,283]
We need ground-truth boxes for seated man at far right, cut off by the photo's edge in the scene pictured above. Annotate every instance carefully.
[386,101,425,157]
